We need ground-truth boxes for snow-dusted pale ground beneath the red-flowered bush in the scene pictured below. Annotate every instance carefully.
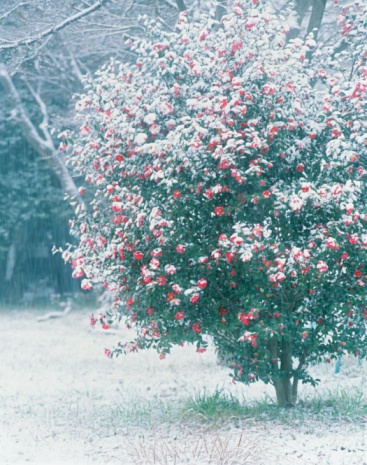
[0,312,367,465]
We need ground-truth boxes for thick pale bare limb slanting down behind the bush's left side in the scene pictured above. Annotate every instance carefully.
[0,64,83,203]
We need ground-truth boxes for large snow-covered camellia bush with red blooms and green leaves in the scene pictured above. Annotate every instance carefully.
[61,0,367,406]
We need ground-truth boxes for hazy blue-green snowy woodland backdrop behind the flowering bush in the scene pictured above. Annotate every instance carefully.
[0,0,343,301]
